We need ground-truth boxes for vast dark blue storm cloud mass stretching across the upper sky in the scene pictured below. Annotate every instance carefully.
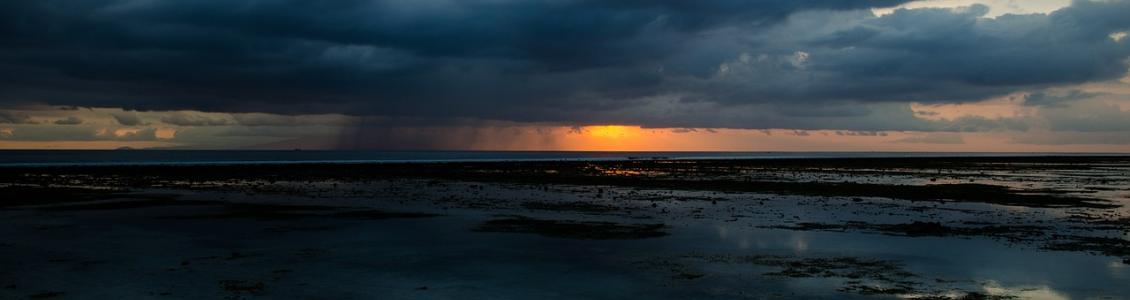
[0,0,1130,130]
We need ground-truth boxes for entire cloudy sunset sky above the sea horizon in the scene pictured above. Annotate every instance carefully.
[0,0,1130,149]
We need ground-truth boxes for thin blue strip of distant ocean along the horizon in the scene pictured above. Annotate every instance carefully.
[0,151,1125,166]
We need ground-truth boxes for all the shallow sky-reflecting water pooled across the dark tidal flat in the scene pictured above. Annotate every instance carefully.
[0,158,1130,299]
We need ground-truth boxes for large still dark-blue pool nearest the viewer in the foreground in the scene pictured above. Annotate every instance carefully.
[0,206,1130,299]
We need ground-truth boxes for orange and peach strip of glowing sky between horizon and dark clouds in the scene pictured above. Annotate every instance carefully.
[0,125,1130,153]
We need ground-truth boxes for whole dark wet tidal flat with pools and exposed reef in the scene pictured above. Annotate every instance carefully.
[0,156,1130,299]
